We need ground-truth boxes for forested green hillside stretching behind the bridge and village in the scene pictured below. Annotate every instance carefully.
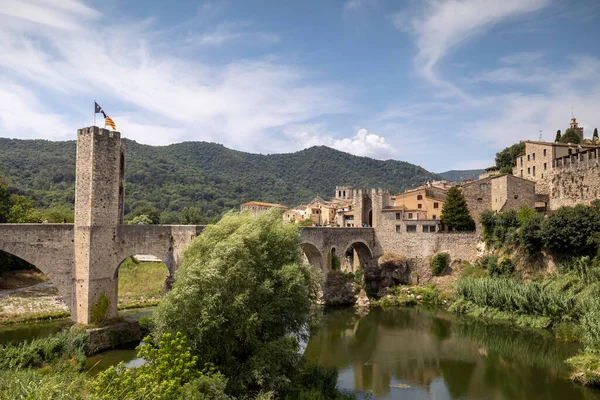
[0,138,440,223]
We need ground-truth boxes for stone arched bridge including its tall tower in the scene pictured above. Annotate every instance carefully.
[0,126,376,324]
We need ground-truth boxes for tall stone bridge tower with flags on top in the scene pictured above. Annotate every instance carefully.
[72,126,125,324]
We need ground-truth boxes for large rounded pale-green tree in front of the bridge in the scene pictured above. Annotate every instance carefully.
[155,209,318,394]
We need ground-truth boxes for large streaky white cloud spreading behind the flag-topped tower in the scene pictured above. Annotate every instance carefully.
[0,0,347,152]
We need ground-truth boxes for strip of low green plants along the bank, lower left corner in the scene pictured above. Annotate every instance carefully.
[0,329,88,370]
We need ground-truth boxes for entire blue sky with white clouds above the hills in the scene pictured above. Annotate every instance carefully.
[0,0,600,172]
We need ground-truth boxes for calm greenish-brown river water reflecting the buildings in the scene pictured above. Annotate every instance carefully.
[0,308,600,400]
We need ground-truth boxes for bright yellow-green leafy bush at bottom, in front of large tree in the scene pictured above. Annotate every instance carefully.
[89,333,229,400]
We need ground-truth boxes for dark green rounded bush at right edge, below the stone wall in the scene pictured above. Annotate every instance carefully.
[542,205,600,257]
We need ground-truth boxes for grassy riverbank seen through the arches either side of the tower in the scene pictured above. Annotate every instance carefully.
[0,259,168,325]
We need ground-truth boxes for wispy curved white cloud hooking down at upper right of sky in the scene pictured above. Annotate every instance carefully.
[391,0,550,100]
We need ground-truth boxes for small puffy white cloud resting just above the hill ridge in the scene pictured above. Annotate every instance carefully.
[285,124,394,159]
